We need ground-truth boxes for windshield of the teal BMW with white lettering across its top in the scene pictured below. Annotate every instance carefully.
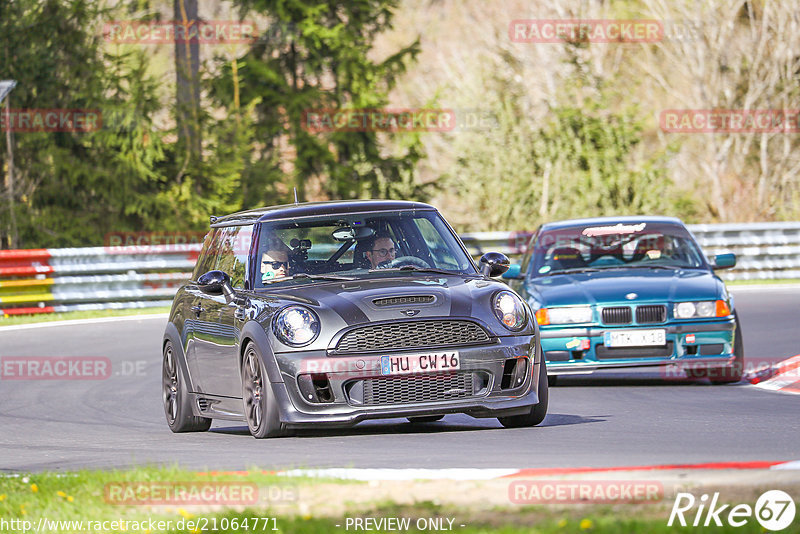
[531,222,706,276]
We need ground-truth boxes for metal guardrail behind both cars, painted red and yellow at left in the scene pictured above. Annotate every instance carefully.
[0,222,800,316]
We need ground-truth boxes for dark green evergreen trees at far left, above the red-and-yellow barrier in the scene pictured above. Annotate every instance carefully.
[0,0,170,247]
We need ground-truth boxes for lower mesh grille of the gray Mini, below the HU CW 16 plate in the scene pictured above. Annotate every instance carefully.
[364,373,475,406]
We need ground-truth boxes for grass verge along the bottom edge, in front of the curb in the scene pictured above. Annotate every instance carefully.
[0,468,800,534]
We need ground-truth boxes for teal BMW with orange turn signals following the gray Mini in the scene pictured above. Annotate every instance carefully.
[504,217,744,383]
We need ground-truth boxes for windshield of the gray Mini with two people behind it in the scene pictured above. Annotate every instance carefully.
[255,211,477,288]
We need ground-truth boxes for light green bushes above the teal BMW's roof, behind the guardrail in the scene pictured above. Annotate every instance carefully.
[446,62,688,230]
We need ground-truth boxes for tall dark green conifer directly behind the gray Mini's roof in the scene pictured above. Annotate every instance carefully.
[212,0,427,207]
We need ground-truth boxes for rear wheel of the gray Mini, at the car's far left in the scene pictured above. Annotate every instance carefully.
[161,341,211,434]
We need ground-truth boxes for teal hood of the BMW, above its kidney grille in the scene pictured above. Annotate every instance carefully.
[527,269,727,307]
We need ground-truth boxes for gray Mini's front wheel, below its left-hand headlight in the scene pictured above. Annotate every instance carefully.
[242,342,287,439]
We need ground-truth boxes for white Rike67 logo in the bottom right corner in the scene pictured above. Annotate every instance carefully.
[667,490,796,532]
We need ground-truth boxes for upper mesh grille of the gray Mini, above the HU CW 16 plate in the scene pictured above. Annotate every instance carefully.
[336,320,490,352]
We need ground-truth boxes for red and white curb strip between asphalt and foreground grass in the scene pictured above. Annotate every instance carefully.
[198,460,800,482]
